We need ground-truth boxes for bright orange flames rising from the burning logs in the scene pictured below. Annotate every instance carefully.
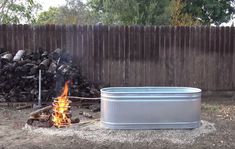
[52,81,71,128]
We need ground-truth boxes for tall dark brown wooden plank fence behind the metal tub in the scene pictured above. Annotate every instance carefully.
[0,25,235,91]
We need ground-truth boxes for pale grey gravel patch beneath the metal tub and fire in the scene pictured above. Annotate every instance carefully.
[23,120,216,144]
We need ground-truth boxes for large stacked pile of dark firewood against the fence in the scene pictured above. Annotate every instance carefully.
[0,49,99,102]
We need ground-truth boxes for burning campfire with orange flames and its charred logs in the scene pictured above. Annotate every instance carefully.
[27,81,80,128]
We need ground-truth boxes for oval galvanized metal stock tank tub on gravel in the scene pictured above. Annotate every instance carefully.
[101,87,201,129]
